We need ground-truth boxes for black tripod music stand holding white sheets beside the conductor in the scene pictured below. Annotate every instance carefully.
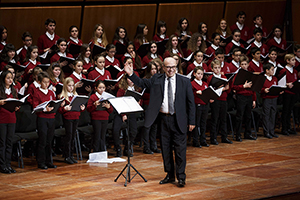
[108,96,147,187]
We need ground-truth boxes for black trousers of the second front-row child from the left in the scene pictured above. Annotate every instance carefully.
[36,117,55,164]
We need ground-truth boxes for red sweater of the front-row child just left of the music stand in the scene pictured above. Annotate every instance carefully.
[87,94,113,120]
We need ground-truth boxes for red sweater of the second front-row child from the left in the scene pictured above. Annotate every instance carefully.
[32,89,56,119]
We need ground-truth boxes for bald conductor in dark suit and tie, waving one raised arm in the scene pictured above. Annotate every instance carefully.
[124,57,195,187]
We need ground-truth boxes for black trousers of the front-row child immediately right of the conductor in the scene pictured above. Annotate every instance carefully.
[193,104,208,143]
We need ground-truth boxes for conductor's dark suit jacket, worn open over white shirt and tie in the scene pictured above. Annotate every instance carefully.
[129,73,195,133]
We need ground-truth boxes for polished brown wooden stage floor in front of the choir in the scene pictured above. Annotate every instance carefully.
[0,131,300,200]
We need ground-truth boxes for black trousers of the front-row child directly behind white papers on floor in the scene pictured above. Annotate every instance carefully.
[92,120,108,152]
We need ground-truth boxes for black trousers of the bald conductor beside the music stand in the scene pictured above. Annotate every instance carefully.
[158,114,187,180]
